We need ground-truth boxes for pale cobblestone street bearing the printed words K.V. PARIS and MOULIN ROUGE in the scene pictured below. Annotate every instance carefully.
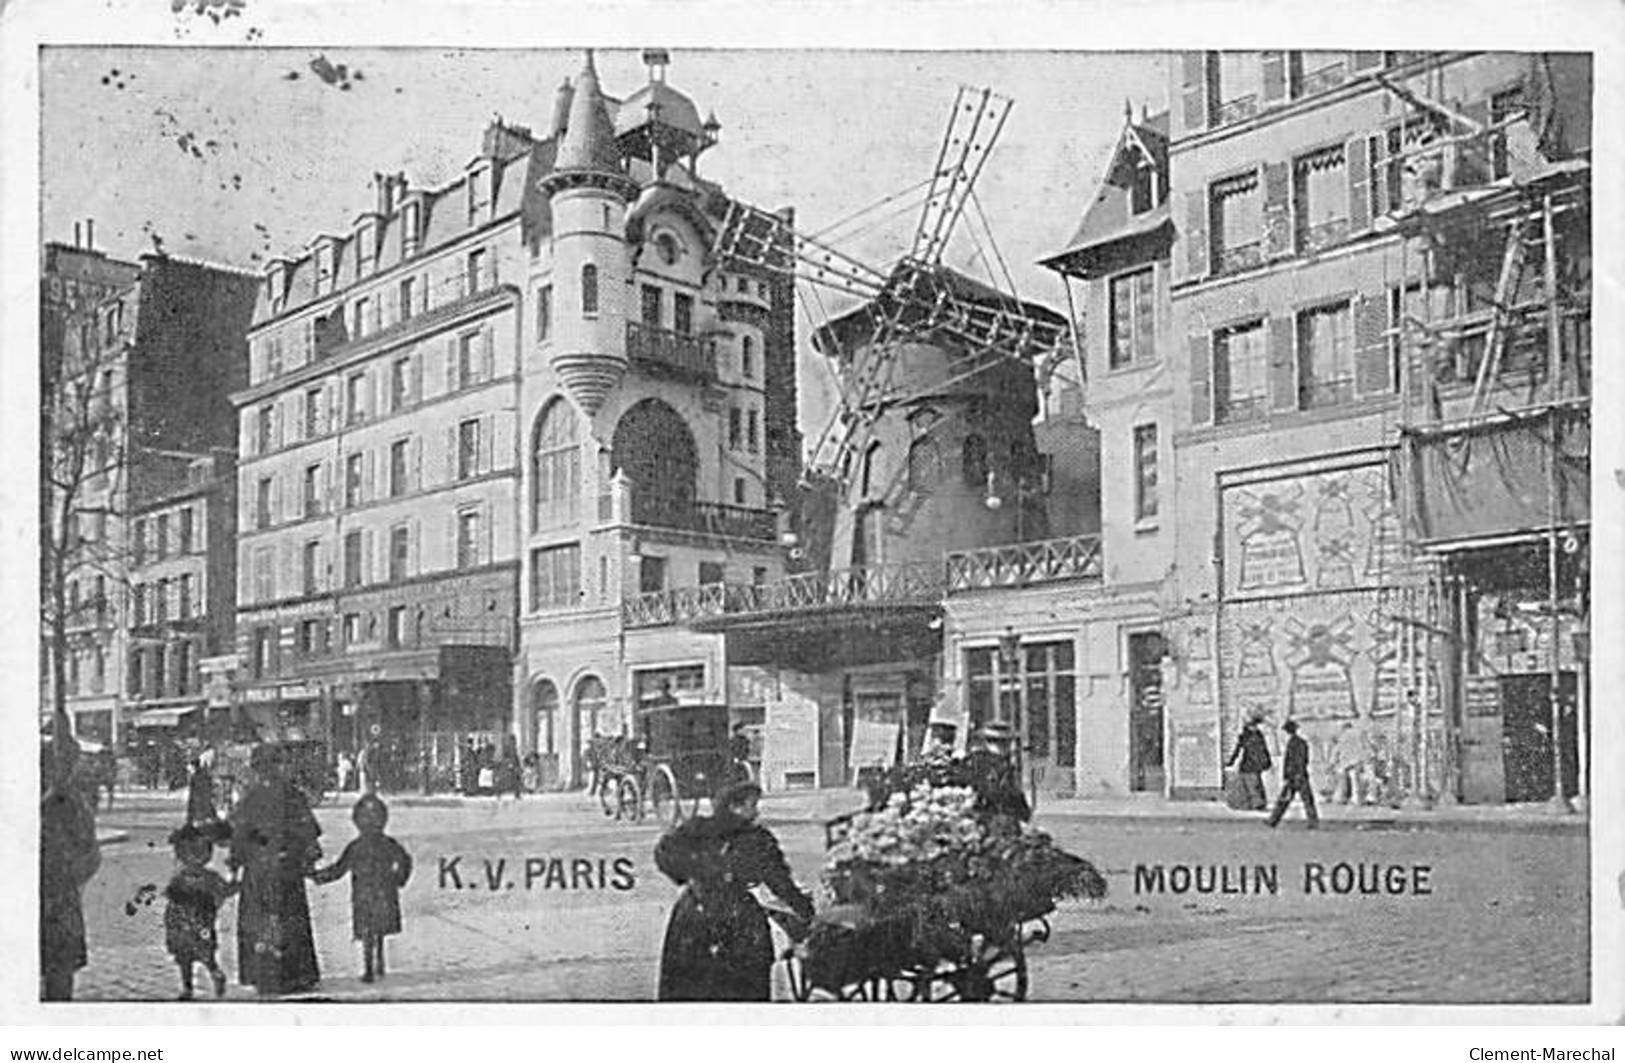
[63,795,1589,1003]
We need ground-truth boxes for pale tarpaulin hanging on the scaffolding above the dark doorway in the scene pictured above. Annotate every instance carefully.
[1412,406,1591,543]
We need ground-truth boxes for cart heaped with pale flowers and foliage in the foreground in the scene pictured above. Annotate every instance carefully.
[783,782,1105,1003]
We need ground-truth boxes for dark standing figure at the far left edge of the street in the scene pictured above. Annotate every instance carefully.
[39,738,101,1001]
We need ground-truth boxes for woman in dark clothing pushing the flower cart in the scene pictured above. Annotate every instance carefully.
[655,782,813,1001]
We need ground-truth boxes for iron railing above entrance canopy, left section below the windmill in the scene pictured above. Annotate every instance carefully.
[621,564,946,627]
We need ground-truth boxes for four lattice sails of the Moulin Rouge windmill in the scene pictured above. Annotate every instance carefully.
[713,86,1069,494]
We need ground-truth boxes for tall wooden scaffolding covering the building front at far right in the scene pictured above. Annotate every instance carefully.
[1383,68,1591,809]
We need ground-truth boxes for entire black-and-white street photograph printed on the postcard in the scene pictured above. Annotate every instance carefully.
[8,0,1619,1027]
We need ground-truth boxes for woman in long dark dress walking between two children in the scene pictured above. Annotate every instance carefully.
[229,746,322,995]
